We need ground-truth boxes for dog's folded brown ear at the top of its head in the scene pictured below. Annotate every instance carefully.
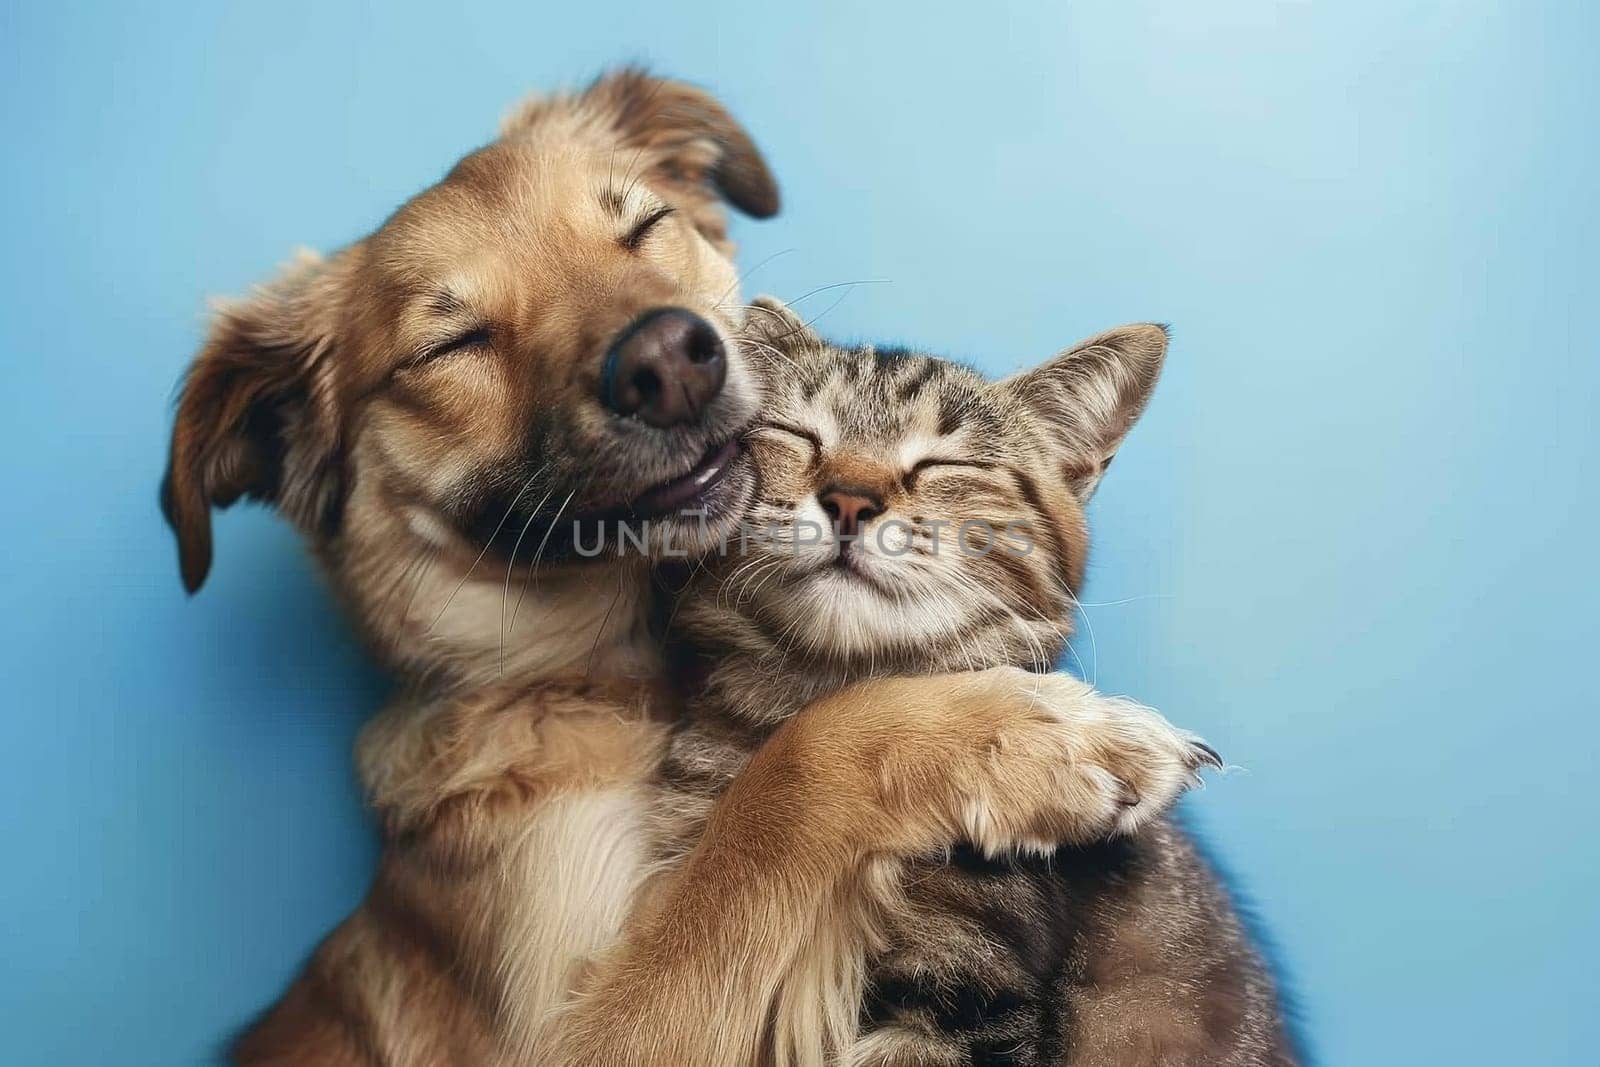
[502,67,779,248]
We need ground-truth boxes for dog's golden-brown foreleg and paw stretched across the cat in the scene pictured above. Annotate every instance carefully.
[544,669,1214,1067]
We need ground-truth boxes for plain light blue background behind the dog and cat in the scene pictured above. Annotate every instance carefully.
[0,0,1600,1067]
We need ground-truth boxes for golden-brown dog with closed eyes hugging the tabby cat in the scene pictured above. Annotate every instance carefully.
[162,69,1203,1065]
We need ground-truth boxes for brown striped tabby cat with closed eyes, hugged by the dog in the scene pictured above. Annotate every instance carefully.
[661,298,1296,1067]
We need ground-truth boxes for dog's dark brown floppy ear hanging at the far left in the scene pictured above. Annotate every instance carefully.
[162,258,339,593]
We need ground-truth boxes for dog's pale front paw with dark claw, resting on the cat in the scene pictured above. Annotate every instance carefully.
[974,672,1222,851]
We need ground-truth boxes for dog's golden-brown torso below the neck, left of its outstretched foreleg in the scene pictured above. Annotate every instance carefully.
[235,683,662,1064]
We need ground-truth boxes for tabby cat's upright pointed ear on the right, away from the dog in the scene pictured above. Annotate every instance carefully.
[1000,323,1166,501]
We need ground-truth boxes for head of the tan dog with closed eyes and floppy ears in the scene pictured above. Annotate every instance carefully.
[163,70,778,683]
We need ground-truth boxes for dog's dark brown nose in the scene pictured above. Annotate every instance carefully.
[600,307,728,429]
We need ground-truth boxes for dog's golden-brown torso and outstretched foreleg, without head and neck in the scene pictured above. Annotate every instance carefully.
[235,670,1209,1065]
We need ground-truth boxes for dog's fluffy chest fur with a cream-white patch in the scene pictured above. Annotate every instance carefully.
[358,681,666,1062]
